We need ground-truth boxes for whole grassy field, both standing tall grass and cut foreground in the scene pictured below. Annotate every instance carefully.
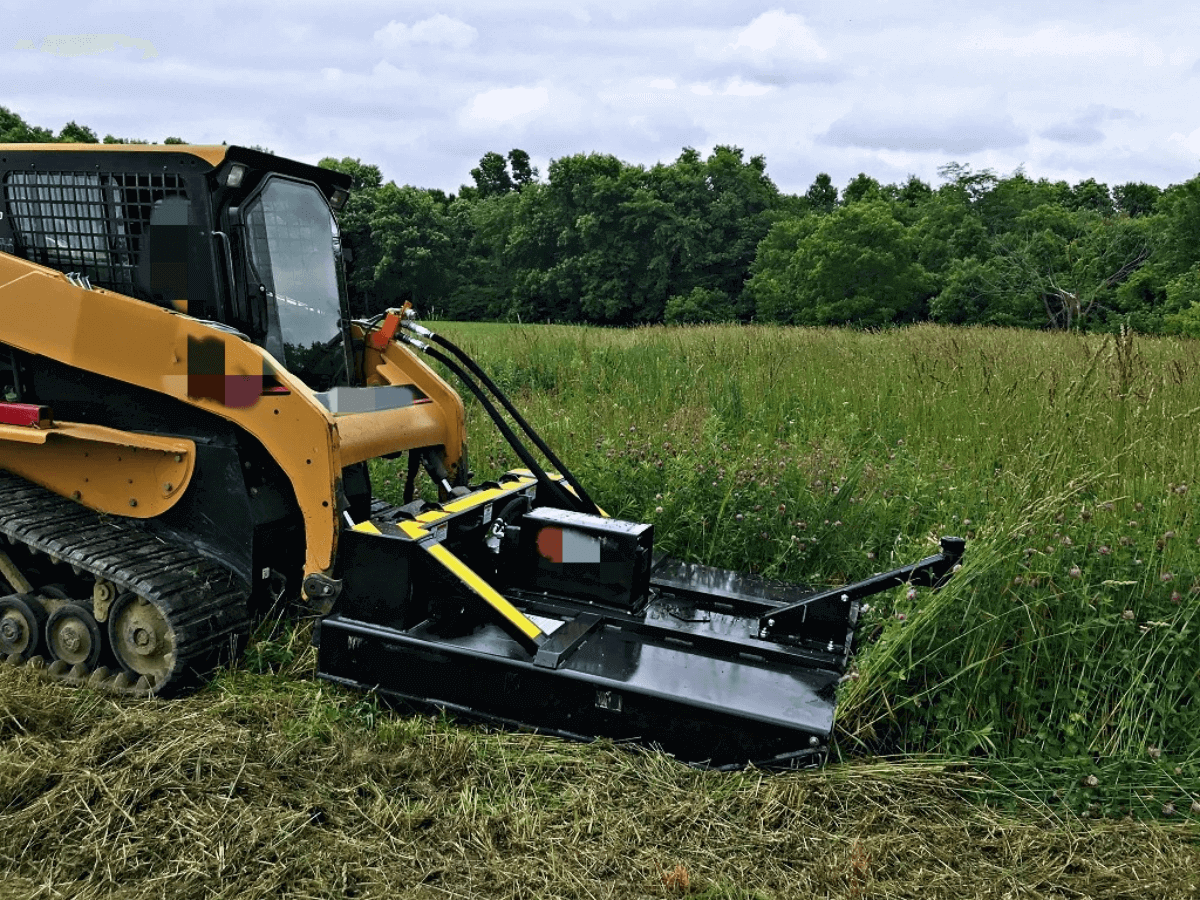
[0,324,1200,898]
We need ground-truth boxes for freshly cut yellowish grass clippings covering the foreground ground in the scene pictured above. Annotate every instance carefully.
[0,648,1200,900]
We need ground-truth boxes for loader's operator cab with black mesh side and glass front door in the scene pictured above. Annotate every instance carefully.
[0,144,353,391]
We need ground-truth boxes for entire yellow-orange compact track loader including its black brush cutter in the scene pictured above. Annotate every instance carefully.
[0,144,962,767]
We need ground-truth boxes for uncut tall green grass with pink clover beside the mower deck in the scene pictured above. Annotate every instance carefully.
[376,324,1200,812]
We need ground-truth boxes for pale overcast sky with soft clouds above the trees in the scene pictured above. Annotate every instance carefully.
[0,0,1200,193]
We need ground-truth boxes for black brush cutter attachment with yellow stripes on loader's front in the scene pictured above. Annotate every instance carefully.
[314,314,964,768]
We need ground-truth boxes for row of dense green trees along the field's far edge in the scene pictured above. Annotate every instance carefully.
[7,107,1200,336]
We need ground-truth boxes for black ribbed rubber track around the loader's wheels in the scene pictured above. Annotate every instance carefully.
[0,472,250,696]
